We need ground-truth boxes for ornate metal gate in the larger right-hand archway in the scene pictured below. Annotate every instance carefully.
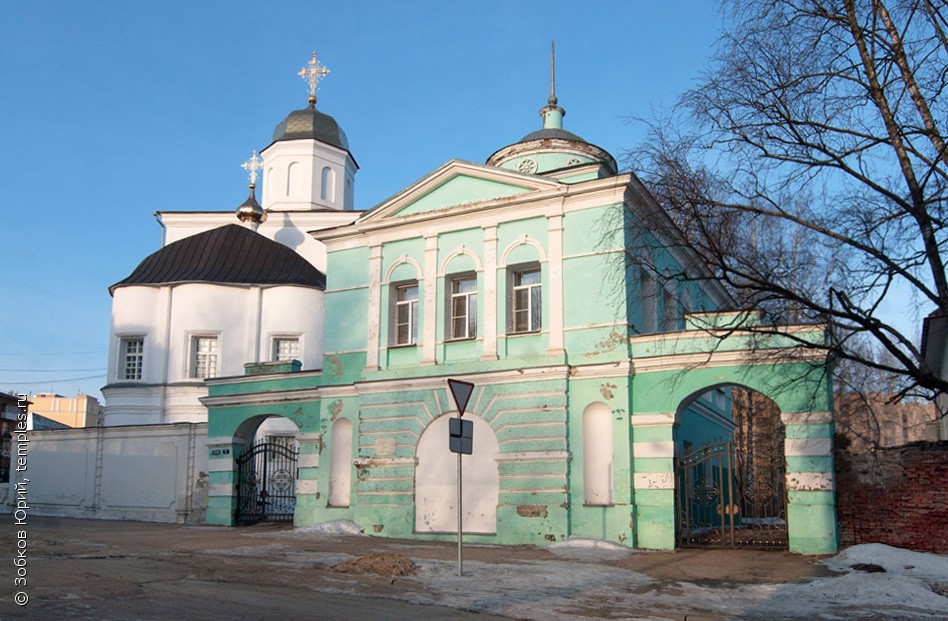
[676,440,787,549]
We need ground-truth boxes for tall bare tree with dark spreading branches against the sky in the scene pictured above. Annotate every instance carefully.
[630,0,948,397]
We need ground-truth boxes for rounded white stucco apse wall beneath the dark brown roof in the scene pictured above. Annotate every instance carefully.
[102,283,324,426]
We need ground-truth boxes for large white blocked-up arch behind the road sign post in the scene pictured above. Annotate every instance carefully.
[415,413,500,535]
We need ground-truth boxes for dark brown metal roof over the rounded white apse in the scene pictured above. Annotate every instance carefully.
[109,224,326,294]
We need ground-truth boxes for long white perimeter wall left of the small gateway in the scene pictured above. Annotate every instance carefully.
[2,423,208,524]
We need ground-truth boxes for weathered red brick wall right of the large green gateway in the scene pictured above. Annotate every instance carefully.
[836,441,948,553]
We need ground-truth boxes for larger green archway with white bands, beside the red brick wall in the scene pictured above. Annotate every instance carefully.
[631,314,837,554]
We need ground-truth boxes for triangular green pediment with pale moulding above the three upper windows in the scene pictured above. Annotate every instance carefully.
[361,160,561,222]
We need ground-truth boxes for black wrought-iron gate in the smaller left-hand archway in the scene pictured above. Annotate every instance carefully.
[235,442,299,525]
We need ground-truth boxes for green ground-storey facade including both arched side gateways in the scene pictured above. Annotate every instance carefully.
[203,313,837,554]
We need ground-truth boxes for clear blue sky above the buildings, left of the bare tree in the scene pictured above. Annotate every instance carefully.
[0,0,720,396]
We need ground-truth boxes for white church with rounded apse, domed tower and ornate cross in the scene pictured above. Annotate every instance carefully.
[102,54,360,426]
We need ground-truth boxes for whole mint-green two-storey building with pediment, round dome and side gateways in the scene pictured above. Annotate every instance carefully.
[202,58,837,553]
